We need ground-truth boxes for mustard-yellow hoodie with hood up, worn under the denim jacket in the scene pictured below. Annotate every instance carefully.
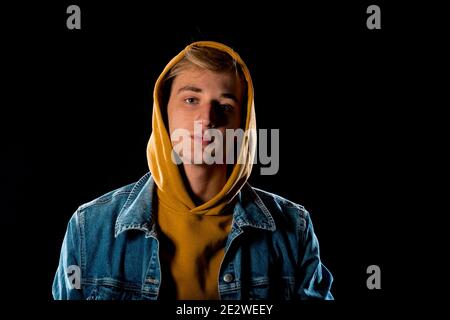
[147,41,256,299]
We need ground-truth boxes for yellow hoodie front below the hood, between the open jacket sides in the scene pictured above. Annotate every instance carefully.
[158,201,233,300]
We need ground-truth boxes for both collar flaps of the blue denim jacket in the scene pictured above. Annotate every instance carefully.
[114,173,276,238]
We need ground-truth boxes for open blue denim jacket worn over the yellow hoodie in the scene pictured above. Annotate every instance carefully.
[53,173,333,300]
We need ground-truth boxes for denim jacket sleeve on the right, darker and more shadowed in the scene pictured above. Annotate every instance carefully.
[296,211,334,300]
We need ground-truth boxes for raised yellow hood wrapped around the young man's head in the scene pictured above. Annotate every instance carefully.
[147,41,256,215]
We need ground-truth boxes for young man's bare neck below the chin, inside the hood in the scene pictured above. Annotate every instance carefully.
[183,164,227,205]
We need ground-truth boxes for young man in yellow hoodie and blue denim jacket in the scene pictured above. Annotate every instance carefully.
[53,41,333,300]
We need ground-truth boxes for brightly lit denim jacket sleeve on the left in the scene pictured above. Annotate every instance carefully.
[52,211,84,300]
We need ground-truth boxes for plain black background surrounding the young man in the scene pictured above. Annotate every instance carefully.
[0,1,442,312]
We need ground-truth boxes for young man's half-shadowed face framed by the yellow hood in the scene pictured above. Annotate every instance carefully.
[167,67,244,164]
